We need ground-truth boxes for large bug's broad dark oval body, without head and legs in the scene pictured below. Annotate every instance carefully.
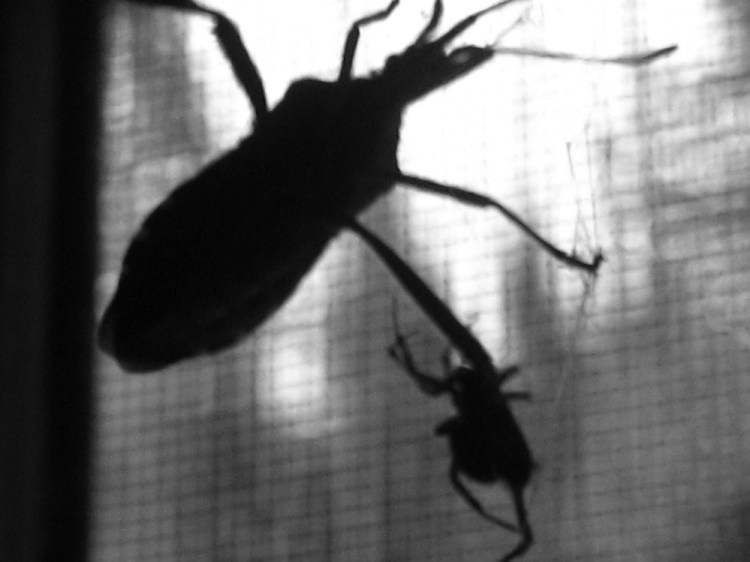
[99,80,400,372]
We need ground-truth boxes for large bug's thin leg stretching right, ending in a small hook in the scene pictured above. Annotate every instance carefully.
[388,172,604,274]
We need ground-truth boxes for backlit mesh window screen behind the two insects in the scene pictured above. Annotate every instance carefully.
[92,0,750,562]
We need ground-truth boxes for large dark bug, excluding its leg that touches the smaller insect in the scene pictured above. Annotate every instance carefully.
[98,0,671,372]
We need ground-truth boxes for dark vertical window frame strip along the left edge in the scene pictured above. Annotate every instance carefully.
[0,0,102,561]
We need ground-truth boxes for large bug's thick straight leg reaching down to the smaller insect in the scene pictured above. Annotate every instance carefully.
[341,217,495,374]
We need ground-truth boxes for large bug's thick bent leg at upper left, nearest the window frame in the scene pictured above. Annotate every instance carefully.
[130,0,268,121]
